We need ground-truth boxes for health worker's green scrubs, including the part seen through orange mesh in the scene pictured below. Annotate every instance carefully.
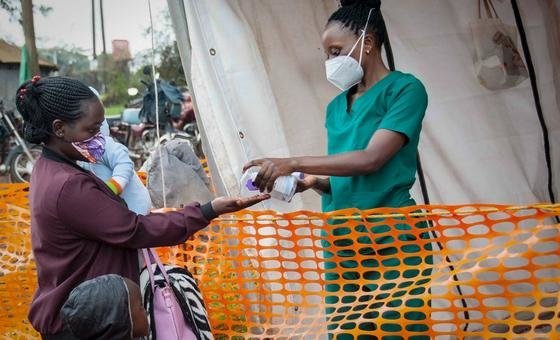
[323,71,433,340]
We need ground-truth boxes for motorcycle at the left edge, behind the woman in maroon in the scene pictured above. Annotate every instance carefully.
[0,100,42,183]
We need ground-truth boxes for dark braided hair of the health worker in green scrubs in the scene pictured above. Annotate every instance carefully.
[327,0,387,49]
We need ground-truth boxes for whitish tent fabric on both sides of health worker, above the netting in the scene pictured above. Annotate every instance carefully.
[184,0,560,210]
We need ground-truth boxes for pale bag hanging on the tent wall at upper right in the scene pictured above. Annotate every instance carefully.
[471,0,528,90]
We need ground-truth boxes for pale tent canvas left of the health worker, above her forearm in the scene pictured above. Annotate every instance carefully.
[185,0,342,210]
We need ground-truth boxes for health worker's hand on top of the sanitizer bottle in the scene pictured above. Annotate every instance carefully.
[243,158,296,192]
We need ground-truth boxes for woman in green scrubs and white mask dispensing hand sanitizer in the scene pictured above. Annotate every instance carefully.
[244,0,431,339]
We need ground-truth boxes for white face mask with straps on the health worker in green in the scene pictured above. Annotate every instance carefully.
[325,8,373,91]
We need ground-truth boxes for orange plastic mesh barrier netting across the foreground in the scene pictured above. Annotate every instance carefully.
[0,185,560,339]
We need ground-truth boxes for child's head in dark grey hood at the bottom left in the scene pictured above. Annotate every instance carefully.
[61,274,149,339]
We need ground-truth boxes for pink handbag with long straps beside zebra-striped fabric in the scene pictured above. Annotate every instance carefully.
[142,248,197,340]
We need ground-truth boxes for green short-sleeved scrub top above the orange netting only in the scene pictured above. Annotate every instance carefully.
[322,71,428,211]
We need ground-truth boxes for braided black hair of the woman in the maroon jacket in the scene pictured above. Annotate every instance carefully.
[16,76,97,144]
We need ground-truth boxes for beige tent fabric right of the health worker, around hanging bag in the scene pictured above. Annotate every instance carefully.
[384,0,558,203]
